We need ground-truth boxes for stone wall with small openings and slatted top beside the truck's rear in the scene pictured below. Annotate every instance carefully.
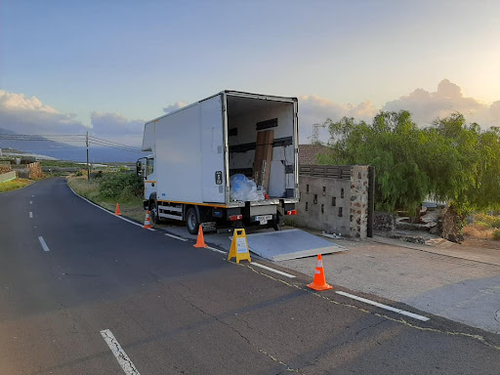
[295,165,368,238]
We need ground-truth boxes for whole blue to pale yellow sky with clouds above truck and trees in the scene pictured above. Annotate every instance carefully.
[0,0,500,145]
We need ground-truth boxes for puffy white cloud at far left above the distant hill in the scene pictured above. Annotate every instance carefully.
[0,90,87,134]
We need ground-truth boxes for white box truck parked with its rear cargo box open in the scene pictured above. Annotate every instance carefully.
[137,90,299,234]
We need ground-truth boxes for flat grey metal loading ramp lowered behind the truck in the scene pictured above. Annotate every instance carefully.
[247,229,345,262]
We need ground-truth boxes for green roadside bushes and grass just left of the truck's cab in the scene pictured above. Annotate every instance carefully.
[67,176,145,222]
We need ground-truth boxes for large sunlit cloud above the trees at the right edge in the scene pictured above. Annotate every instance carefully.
[382,79,500,128]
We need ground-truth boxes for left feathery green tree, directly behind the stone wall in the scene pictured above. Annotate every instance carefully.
[320,111,430,212]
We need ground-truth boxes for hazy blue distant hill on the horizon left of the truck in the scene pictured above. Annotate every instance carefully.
[0,128,144,163]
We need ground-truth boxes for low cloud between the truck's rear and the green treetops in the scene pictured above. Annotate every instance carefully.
[299,95,378,143]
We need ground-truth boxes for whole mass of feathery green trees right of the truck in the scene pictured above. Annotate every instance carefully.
[319,111,500,235]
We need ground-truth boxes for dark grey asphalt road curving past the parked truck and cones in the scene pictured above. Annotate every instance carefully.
[0,179,500,375]
